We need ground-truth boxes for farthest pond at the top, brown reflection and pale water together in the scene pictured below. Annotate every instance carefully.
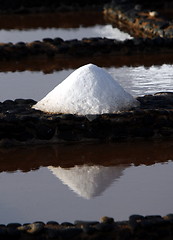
[0,12,131,43]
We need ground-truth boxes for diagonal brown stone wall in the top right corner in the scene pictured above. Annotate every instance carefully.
[104,0,173,38]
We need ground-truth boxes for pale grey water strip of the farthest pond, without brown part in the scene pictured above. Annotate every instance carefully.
[0,24,131,43]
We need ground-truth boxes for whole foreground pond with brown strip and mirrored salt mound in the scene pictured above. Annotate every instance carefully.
[0,143,173,223]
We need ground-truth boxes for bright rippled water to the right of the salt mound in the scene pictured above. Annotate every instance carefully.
[107,64,173,96]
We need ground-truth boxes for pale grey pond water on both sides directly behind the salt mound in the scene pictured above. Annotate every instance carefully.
[0,64,173,101]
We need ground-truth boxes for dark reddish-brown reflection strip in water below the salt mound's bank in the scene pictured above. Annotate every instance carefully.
[0,140,173,172]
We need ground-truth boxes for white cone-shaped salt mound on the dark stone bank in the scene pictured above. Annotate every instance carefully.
[33,64,139,115]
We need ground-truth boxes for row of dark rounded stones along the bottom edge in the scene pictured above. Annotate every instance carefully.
[0,214,173,240]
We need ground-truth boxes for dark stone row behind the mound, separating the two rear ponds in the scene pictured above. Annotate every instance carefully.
[0,37,173,61]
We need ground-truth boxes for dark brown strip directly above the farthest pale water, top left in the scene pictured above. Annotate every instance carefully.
[0,11,105,30]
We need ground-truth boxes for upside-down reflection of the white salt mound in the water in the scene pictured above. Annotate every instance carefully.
[48,165,125,199]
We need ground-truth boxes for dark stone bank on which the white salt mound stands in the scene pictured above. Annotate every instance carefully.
[0,93,173,146]
